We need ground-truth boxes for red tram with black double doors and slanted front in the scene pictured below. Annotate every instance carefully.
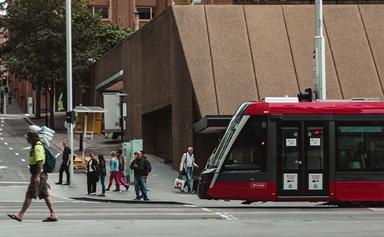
[197,101,384,203]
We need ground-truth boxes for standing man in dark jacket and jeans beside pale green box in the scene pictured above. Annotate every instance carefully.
[130,151,149,201]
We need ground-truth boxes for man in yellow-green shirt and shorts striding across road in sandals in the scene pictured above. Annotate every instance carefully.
[8,132,57,222]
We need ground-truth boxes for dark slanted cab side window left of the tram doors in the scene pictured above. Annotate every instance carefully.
[224,117,267,171]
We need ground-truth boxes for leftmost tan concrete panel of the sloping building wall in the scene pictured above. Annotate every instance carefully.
[173,6,218,117]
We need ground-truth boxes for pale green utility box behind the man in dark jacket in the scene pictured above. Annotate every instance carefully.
[122,139,143,182]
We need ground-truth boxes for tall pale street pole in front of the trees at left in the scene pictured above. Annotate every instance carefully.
[65,0,74,185]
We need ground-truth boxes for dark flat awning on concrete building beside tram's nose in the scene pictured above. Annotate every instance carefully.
[193,115,232,133]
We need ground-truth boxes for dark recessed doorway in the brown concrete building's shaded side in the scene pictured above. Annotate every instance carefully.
[142,106,172,163]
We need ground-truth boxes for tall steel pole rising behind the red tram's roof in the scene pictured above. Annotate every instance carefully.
[315,0,327,100]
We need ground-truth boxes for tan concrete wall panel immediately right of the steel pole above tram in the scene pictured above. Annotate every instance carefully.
[324,5,382,99]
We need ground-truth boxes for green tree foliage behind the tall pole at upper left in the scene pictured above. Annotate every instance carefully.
[0,0,130,84]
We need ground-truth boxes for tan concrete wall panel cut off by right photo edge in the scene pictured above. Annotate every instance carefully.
[359,5,384,99]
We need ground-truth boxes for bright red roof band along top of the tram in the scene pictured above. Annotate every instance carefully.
[244,102,384,115]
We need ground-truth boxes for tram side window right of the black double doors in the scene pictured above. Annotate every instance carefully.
[337,122,384,171]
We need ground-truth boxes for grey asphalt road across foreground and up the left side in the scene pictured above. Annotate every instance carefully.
[0,116,384,237]
